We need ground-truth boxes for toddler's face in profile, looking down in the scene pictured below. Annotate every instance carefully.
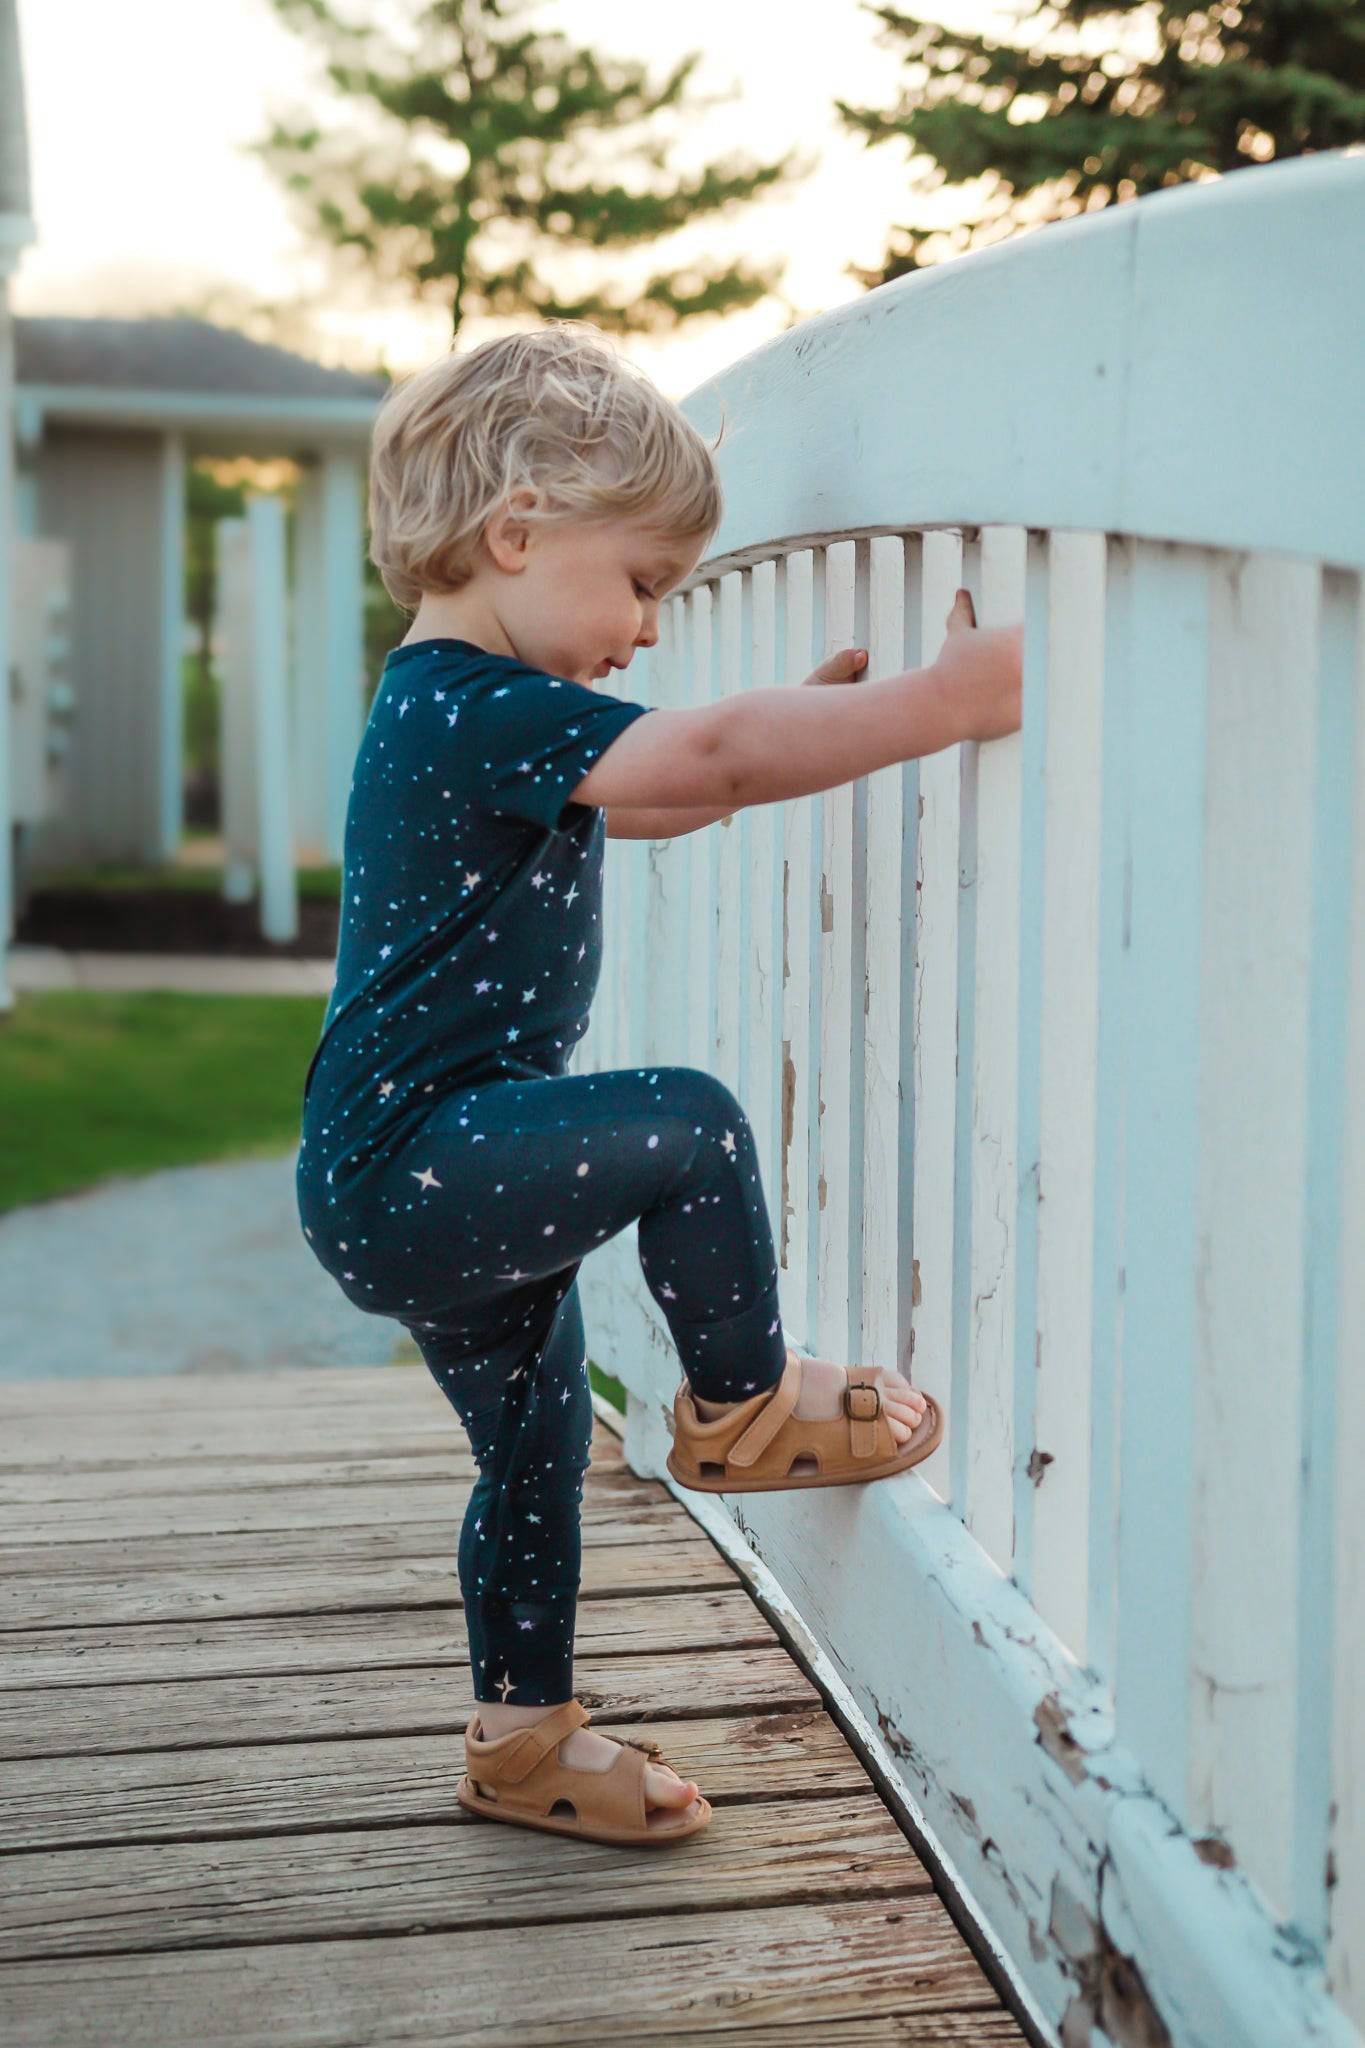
[495,518,706,688]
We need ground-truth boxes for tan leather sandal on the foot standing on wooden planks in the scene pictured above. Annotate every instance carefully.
[454,1700,710,1847]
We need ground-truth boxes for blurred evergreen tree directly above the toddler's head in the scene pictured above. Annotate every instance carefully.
[254,0,810,334]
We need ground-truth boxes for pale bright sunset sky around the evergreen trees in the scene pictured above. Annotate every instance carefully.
[10,0,1047,397]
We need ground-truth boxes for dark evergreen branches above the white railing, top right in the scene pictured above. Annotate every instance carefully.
[835,0,1365,285]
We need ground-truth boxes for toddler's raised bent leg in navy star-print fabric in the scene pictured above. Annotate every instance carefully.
[386,1067,786,1401]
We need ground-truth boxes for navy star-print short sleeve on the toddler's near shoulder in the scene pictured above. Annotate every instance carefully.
[456,664,653,831]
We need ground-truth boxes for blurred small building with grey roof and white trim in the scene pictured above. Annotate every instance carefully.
[14,317,385,862]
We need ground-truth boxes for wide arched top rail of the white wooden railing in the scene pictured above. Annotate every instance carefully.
[684,150,1365,588]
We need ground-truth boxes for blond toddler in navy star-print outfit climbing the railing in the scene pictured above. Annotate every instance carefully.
[297,322,1019,1841]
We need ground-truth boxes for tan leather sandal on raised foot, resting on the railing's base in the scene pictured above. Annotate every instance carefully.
[665,1350,943,1493]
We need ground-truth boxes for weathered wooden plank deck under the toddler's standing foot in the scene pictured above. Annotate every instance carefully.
[0,1366,1025,2048]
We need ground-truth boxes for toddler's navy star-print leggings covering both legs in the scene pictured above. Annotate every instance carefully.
[388,1067,786,1706]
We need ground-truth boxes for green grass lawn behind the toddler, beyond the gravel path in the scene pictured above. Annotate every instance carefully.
[0,987,626,1409]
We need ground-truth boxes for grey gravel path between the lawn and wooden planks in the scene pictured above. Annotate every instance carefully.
[0,1151,417,1380]
